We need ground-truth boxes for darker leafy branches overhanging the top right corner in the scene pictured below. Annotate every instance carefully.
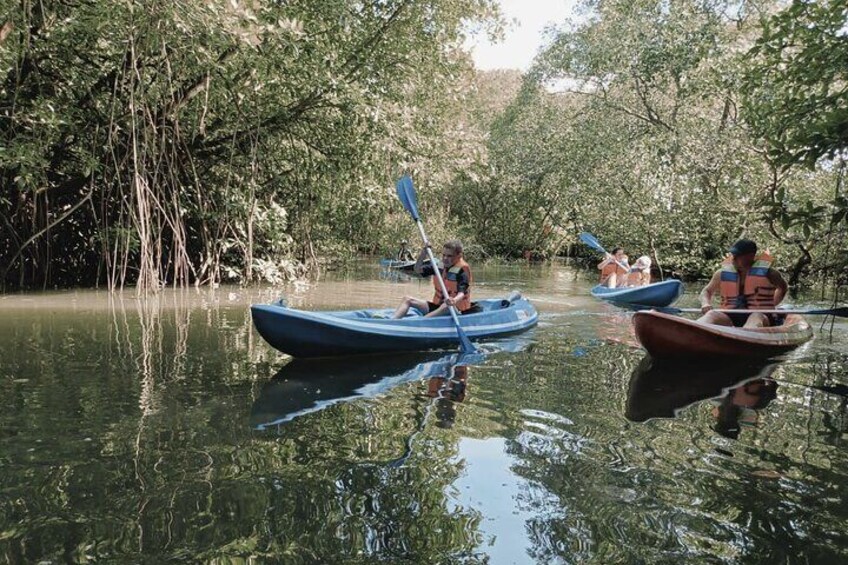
[741,0,848,167]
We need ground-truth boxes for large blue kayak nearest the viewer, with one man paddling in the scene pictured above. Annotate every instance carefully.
[250,293,539,357]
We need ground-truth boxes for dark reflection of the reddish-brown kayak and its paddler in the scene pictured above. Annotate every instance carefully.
[624,356,777,426]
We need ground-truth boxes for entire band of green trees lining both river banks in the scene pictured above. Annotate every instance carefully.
[0,0,848,289]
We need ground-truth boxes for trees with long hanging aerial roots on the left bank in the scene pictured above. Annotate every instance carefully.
[0,0,495,288]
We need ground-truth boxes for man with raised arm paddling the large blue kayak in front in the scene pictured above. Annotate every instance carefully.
[392,239,477,318]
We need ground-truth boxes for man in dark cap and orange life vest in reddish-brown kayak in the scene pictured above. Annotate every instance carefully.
[698,239,788,328]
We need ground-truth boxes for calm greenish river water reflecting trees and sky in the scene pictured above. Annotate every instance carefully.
[0,264,848,563]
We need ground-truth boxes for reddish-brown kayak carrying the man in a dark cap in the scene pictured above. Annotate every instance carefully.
[633,311,813,359]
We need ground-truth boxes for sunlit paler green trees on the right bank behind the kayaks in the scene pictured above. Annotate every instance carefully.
[448,0,846,283]
